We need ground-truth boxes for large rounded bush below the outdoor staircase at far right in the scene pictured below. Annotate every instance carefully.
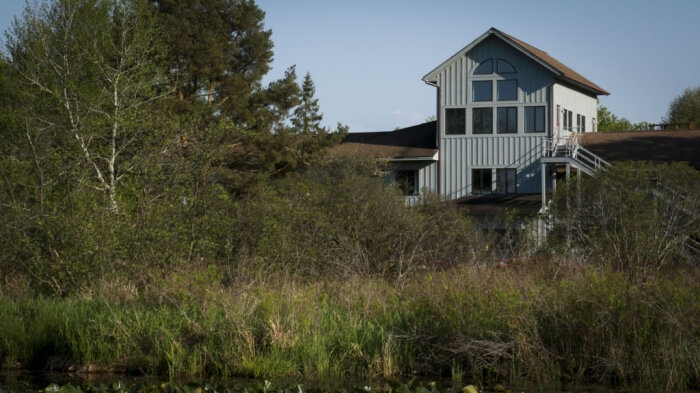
[548,162,700,276]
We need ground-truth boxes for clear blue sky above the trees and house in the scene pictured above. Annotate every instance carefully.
[0,0,700,131]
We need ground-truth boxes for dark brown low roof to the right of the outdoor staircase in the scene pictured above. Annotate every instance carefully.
[581,130,700,170]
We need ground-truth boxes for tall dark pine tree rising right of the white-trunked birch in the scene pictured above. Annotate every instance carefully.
[151,0,299,132]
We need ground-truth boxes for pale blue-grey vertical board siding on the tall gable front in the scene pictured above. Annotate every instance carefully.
[434,37,560,199]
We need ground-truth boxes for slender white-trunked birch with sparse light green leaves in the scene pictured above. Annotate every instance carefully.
[7,0,162,214]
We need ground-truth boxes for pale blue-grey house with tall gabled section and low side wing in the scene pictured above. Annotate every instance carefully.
[338,28,700,215]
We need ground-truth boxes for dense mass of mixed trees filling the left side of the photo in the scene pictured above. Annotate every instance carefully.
[0,0,356,292]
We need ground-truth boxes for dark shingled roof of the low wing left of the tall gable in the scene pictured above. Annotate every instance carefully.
[331,121,437,158]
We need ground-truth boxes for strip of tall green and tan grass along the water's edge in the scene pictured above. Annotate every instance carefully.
[0,267,700,389]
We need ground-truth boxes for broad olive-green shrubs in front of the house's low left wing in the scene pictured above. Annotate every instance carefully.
[228,160,473,279]
